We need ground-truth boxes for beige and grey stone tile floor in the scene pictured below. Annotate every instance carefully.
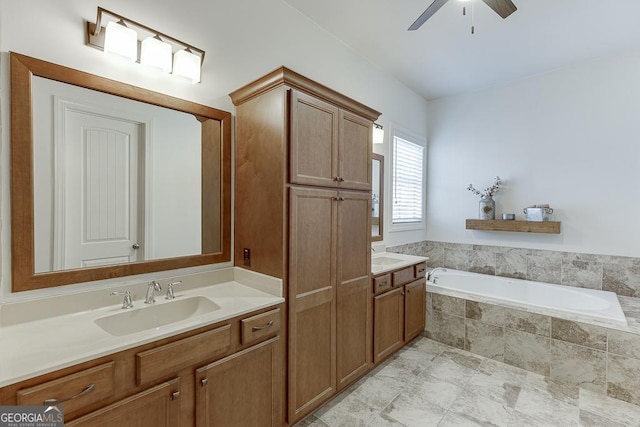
[297,337,640,427]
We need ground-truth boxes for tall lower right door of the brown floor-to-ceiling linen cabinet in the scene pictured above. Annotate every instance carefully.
[337,191,372,390]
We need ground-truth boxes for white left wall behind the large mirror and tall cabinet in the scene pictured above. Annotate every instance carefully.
[0,0,427,297]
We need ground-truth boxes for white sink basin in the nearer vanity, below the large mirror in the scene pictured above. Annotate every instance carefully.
[94,297,220,336]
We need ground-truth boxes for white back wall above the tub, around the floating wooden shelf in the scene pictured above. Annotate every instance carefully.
[427,50,640,257]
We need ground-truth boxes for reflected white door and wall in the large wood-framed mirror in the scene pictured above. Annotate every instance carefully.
[32,77,202,273]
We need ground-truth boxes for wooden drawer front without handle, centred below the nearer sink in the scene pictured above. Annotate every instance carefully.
[136,325,231,385]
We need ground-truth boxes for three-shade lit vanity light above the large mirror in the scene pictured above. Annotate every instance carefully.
[87,7,204,83]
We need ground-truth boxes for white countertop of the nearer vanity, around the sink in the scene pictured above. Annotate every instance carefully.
[0,267,284,387]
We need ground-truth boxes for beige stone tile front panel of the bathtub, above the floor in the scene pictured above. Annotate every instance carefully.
[425,292,640,405]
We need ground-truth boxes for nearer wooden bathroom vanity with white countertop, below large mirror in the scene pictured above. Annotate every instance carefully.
[0,268,284,426]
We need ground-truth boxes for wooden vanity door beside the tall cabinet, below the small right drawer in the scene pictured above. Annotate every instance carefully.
[196,337,282,427]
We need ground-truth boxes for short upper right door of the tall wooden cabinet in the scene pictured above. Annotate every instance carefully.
[338,110,373,190]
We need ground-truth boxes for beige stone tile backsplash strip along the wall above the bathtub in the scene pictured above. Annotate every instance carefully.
[387,241,640,298]
